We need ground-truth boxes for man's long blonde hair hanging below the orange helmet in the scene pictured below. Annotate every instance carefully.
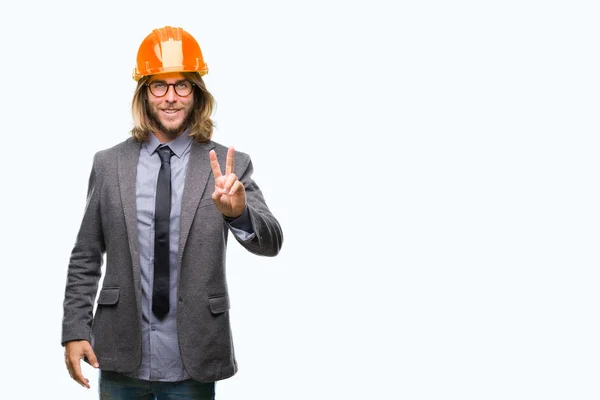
[131,72,215,143]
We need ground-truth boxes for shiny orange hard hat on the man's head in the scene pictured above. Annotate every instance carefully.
[133,26,208,81]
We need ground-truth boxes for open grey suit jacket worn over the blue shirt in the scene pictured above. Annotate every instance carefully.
[62,138,283,381]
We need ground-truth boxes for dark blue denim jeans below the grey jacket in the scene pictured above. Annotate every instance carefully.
[98,371,215,400]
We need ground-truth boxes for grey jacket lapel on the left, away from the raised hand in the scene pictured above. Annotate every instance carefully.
[117,138,142,304]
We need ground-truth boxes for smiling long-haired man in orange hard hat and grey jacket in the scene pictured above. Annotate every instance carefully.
[62,26,283,400]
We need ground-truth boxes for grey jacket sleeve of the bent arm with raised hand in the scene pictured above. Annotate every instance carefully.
[234,155,283,257]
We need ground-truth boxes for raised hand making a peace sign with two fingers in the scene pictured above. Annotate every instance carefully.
[208,147,246,218]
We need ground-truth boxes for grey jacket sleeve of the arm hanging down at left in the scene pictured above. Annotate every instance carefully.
[61,153,106,346]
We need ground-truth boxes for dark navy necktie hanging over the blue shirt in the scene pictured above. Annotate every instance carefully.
[152,146,173,319]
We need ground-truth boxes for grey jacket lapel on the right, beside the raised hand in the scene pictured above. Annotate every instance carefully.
[177,141,215,265]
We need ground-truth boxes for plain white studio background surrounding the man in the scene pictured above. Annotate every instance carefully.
[0,0,600,400]
